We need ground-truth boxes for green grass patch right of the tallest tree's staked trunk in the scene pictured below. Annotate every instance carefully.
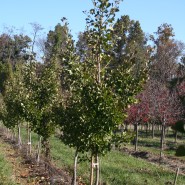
[102,151,185,185]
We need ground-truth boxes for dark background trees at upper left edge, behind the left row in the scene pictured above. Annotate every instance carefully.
[0,29,31,94]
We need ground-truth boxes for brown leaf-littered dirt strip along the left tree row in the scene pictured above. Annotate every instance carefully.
[0,129,71,185]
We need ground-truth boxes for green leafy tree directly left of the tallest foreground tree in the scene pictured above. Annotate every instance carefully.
[24,60,60,163]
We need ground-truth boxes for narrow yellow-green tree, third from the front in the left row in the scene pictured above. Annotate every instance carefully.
[4,64,24,148]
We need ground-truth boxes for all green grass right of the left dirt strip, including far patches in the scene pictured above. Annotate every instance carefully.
[1,123,185,185]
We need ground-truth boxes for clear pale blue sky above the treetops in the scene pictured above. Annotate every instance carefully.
[0,0,185,42]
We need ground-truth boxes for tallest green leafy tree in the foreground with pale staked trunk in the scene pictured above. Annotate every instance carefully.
[57,0,148,185]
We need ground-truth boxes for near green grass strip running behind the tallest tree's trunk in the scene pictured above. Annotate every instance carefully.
[51,137,185,185]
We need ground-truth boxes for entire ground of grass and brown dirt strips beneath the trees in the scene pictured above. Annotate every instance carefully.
[0,125,185,185]
